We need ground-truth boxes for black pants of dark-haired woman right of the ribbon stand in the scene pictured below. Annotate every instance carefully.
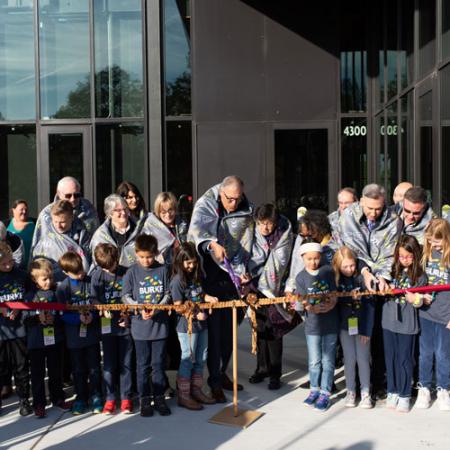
[255,308,283,380]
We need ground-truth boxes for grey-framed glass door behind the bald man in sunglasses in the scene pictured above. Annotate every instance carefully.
[39,125,93,208]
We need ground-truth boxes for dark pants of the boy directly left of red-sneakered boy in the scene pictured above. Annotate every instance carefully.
[70,344,102,403]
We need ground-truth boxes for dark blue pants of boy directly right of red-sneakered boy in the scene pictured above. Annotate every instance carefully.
[134,339,166,398]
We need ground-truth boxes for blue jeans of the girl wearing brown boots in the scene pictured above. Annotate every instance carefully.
[178,329,208,379]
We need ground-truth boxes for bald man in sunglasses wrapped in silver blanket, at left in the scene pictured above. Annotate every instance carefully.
[31,177,100,258]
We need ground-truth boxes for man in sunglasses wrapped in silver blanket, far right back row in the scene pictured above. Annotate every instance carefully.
[399,186,437,245]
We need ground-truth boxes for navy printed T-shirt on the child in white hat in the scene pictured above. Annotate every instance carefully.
[295,265,339,336]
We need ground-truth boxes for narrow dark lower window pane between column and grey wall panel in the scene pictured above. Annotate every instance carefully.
[166,120,192,196]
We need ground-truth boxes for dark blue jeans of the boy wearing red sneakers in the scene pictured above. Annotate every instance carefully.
[102,334,133,400]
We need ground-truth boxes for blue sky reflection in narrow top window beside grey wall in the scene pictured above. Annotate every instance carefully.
[164,0,190,83]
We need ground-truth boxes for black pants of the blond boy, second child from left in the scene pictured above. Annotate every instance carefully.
[28,342,64,408]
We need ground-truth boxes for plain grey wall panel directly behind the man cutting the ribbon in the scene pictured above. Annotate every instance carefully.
[194,122,268,204]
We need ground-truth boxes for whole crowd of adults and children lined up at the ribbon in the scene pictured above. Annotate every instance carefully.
[0,176,450,418]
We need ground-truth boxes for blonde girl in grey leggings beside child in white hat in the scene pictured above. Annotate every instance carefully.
[333,246,375,409]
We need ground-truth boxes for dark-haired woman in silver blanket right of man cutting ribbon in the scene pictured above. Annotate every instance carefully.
[248,203,294,389]
